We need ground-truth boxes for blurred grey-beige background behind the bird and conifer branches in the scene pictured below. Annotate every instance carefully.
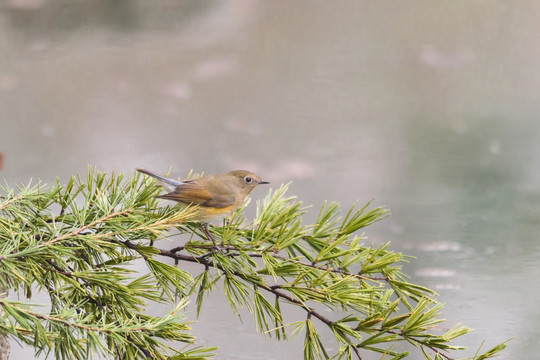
[0,0,540,359]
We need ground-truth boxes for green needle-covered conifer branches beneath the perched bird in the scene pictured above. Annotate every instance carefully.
[0,169,505,360]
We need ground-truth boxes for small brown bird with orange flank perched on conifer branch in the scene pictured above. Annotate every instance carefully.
[137,169,269,243]
